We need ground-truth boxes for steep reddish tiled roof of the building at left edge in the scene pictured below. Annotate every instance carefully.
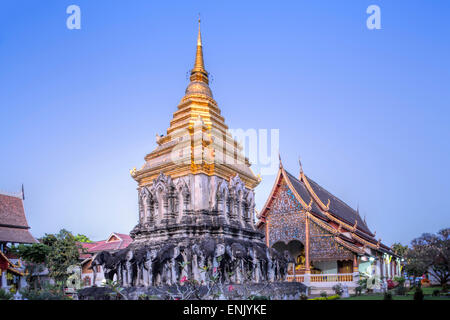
[0,194,37,243]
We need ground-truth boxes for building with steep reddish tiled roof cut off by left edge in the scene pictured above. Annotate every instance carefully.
[0,192,38,290]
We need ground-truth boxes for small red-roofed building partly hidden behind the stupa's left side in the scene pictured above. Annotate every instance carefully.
[79,232,133,287]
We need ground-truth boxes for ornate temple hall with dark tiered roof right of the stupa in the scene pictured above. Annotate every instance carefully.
[257,159,401,294]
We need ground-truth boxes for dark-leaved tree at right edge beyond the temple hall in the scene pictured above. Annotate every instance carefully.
[406,228,450,287]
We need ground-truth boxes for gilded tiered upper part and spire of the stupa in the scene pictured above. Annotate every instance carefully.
[131,19,259,189]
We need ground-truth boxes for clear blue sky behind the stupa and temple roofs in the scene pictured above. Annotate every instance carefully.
[0,0,450,245]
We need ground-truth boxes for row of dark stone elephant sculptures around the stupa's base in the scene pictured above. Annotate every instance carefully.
[91,238,292,287]
